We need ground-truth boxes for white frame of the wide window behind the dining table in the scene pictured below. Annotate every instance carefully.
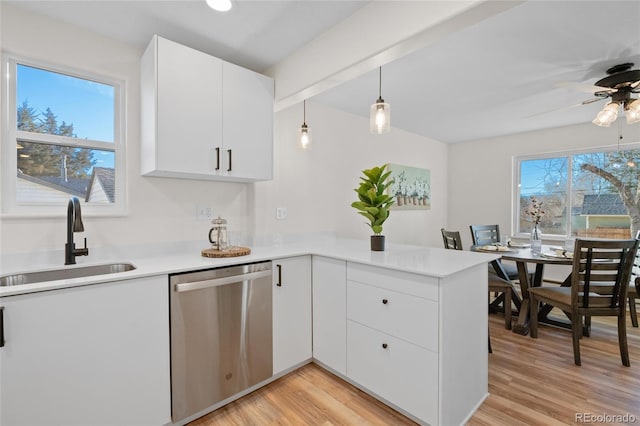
[511,142,640,241]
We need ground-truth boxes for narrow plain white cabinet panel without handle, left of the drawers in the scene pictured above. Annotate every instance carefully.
[312,256,347,375]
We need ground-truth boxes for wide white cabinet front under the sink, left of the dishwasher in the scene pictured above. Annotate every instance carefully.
[0,275,171,426]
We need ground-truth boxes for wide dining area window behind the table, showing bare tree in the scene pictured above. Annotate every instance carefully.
[514,146,640,238]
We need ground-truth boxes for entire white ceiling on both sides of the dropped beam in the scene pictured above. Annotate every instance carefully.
[3,0,640,142]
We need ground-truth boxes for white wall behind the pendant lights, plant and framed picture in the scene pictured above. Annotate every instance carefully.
[255,102,447,246]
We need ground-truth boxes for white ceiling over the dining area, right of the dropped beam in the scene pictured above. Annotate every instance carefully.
[307,1,640,142]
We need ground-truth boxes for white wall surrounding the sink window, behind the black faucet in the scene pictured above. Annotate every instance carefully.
[1,4,253,256]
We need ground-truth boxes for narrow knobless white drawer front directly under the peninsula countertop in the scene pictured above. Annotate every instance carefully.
[347,262,439,301]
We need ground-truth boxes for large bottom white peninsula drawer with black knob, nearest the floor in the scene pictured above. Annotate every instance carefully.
[347,321,438,425]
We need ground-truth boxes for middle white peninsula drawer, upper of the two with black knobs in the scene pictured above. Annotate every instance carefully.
[347,281,438,352]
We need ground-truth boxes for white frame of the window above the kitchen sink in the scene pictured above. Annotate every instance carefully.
[0,52,127,218]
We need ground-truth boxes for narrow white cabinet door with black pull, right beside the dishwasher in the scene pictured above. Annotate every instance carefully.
[273,256,311,374]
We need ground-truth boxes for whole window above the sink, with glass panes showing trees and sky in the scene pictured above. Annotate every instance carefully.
[2,58,125,216]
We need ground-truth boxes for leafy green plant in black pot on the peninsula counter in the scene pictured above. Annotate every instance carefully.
[351,164,394,251]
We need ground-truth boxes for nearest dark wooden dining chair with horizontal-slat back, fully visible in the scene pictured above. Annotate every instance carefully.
[529,239,638,367]
